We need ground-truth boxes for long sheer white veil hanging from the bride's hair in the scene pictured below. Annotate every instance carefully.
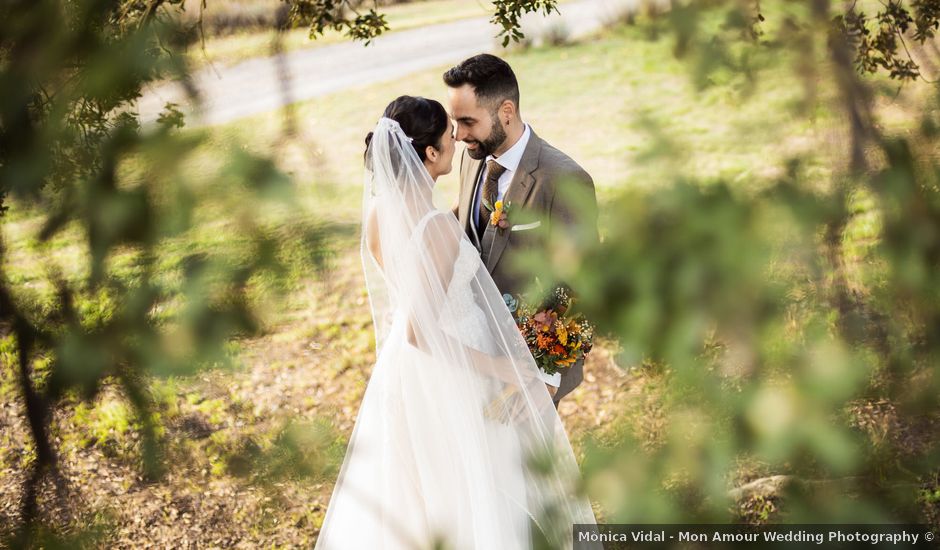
[324,118,595,548]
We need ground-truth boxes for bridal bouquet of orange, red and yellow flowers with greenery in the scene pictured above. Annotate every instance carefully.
[503,286,594,380]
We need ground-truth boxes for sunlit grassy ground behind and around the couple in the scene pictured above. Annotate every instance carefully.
[0,11,928,547]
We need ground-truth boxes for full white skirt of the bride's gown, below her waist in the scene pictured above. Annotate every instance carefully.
[317,337,536,550]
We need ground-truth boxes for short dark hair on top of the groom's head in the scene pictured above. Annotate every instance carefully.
[444,53,519,109]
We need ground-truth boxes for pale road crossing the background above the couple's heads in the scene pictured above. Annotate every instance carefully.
[138,0,638,125]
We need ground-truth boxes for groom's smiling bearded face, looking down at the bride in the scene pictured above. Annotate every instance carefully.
[448,84,506,160]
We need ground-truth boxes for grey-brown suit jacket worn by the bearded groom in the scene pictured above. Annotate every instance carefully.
[455,127,598,406]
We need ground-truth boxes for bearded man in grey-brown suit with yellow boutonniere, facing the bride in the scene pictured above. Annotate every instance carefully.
[444,54,597,407]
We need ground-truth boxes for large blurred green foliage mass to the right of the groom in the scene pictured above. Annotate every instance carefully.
[566,0,940,525]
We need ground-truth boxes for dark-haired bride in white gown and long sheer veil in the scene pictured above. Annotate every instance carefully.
[317,96,595,550]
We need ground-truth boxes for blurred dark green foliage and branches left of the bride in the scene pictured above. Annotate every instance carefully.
[0,0,336,546]
